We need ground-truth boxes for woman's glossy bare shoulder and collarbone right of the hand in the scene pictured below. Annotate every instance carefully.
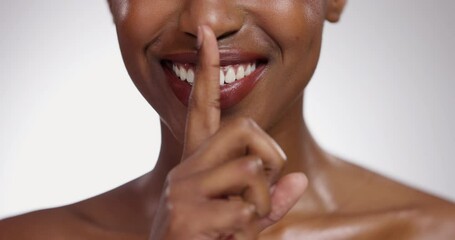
[260,159,455,240]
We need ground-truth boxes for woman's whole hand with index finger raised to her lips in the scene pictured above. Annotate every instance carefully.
[151,26,307,240]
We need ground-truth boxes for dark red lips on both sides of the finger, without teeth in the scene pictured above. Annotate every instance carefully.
[161,50,267,110]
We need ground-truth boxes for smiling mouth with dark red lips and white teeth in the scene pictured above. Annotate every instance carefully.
[162,52,267,110]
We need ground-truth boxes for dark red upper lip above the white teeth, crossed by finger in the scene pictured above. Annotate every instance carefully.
[163,50,267,66]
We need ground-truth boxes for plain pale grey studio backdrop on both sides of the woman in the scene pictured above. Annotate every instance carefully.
[0,0,455,218]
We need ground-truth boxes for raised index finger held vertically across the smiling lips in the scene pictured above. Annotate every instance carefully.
[183,26,221,158]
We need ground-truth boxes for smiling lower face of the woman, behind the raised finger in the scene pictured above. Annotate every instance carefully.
[110,0,344,140]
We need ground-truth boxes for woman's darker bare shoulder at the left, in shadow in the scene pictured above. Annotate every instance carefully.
[0,180,149,240]
